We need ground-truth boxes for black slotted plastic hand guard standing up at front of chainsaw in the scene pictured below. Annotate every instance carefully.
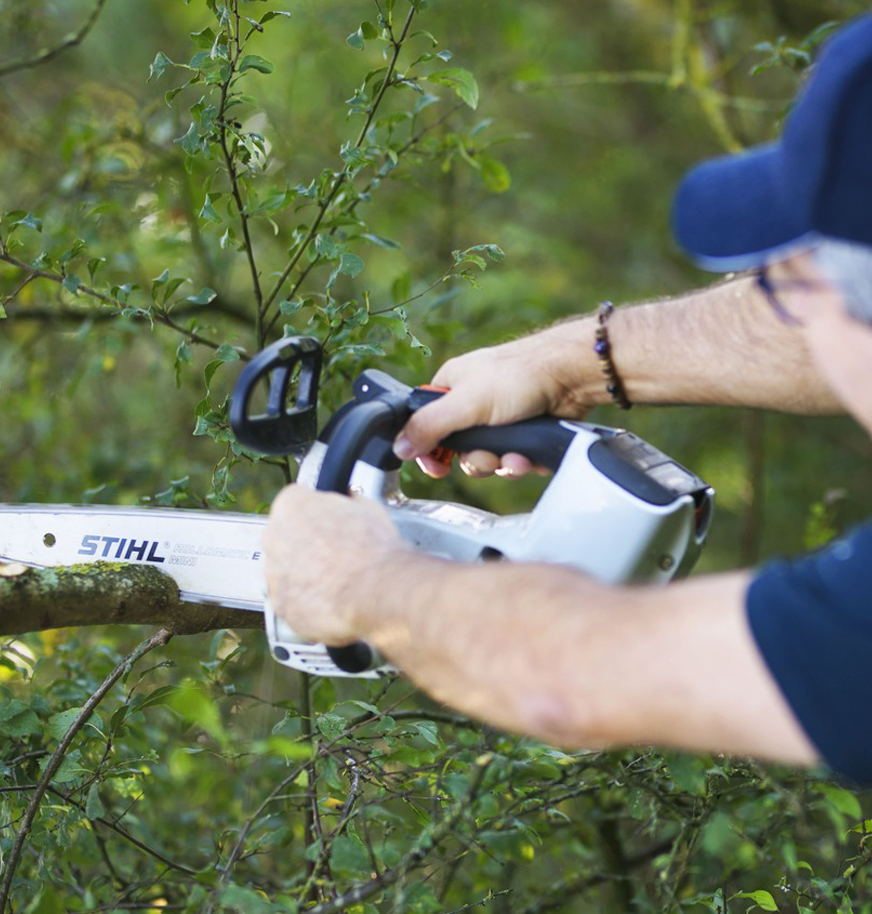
[229,336,322,454]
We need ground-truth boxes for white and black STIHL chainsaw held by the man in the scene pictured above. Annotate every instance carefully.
[0,337,714,678]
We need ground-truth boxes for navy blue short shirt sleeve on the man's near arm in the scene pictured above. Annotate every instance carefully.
[747,523,872,784]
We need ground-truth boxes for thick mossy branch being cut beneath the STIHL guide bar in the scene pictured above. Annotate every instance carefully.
[0,562,263,635]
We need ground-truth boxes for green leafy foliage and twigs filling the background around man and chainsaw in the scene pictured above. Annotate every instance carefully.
[0,0,872,914]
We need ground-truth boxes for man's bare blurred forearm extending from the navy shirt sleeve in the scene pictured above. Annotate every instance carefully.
[357,553,815,763]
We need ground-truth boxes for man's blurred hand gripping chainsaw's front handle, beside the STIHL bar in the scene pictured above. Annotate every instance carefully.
[264,485,406,647]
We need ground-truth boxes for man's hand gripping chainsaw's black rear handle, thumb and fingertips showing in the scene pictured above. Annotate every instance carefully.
[394,320,593,477]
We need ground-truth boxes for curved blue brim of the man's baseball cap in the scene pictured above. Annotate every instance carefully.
[672,144,816,272]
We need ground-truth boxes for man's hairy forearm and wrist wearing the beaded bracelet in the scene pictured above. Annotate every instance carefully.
[543,277,843,414]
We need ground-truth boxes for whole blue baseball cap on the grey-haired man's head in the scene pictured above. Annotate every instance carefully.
[672,16,872,272]
